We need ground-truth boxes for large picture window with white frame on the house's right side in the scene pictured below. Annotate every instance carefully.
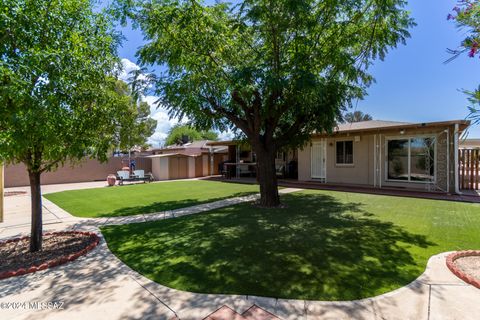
[387,137,435,182]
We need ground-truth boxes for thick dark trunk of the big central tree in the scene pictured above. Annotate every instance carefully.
[255,150,280,208]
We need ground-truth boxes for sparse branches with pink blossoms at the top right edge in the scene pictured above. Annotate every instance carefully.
[447,0,480,123]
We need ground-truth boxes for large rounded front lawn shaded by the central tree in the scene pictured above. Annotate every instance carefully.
[102,190,480,300]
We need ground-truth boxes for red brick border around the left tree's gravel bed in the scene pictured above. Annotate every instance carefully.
[0,231,100,280]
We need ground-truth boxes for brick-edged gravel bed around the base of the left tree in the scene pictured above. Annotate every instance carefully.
[0,231,99,279]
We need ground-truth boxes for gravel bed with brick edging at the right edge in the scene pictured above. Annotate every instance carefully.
[447,250,480,289]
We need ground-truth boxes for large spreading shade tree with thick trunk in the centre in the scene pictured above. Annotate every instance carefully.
[117,0,413,207]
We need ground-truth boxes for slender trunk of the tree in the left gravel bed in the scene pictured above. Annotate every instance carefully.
[28,171,42,252]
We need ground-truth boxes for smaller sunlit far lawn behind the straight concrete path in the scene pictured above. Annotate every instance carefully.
[44,180,259,218]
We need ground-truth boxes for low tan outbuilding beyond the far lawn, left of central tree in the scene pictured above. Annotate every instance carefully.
[146,140,228,180]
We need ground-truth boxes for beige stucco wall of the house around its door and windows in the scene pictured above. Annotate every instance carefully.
[298,127,454,191]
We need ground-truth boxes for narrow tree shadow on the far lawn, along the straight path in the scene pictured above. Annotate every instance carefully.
[95,192,257,218]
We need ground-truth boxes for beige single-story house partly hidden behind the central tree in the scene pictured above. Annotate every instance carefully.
[210,120,472,193]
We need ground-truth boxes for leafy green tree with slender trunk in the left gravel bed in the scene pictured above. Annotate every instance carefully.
[0,0,130,251]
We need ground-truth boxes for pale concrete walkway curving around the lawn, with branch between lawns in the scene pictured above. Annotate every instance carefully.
[0,181,480,320]
